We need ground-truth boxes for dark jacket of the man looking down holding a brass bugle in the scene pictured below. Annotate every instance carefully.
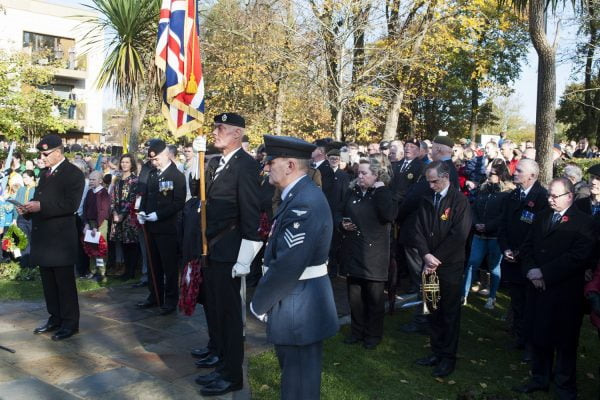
[414,185,471,269]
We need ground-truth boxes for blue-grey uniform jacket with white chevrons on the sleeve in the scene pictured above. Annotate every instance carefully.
[252,177,339,346]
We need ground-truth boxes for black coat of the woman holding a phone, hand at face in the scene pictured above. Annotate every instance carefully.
[336,185,397,282]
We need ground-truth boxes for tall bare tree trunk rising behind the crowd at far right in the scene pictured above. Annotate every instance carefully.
[529,0,556,184]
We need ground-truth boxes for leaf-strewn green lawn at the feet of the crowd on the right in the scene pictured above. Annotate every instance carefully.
[249,295,600,400]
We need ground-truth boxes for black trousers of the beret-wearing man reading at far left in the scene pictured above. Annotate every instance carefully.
[40,265,79,330]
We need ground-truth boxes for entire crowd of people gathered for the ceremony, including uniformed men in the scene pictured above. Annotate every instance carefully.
[5,123,600,399]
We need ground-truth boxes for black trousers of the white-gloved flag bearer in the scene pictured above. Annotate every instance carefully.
[202,260,244,384]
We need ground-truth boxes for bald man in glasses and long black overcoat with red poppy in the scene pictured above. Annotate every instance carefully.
[514,178,594,399]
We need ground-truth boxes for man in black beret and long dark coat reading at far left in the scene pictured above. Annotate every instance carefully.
[17,135,85,340]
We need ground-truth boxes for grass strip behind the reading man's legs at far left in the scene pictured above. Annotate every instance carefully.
[0,277,137,301]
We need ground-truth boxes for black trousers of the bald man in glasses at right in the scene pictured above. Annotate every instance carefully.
[531,338,578,400]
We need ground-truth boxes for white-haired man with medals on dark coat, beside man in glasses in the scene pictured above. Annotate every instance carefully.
[498,159,548,357]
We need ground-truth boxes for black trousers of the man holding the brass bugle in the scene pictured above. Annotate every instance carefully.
[429,262,464,360]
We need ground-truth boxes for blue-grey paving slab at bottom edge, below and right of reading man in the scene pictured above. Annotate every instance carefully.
[58,367,156,398]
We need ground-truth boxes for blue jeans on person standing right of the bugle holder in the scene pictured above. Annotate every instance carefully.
[463,235,502,298]
